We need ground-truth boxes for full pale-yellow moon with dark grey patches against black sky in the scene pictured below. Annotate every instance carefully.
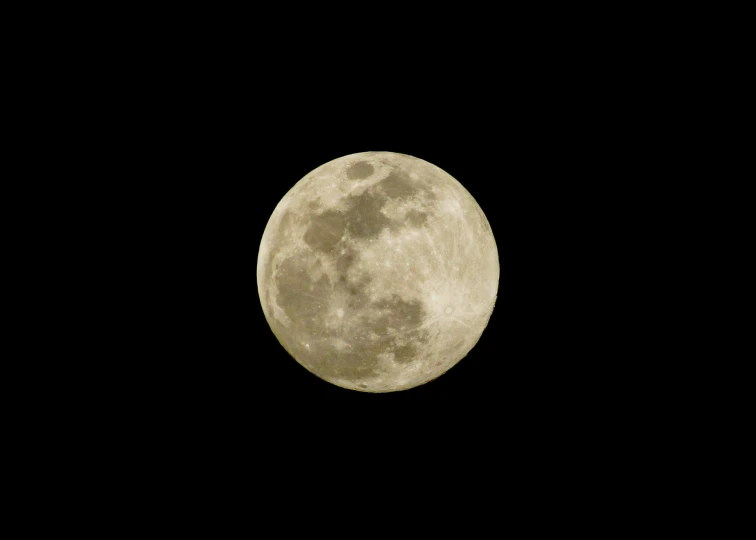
[257,152,499,392]
